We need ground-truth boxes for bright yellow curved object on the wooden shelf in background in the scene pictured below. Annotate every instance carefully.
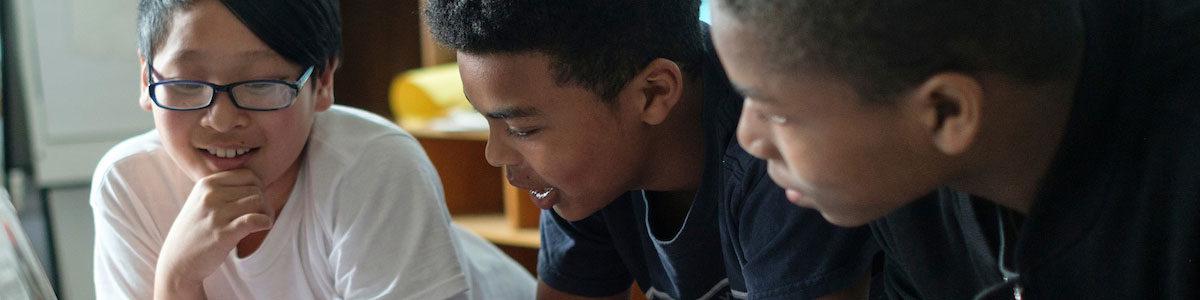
[388,64,472,127]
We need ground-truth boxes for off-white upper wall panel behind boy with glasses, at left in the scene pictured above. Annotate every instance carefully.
[6,0,152,186]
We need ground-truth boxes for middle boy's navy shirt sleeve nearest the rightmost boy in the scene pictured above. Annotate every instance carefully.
[730,161,878,299]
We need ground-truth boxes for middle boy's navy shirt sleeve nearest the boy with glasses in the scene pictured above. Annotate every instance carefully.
[538,199,632,296]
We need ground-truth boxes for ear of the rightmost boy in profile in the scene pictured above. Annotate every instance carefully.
[907,72,984,156]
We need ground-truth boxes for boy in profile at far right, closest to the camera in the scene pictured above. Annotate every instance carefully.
[713,0,1200,299]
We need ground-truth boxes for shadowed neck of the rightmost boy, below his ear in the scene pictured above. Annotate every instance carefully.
[954,77,1074,215]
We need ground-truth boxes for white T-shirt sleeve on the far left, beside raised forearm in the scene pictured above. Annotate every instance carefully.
[89,164,164,299]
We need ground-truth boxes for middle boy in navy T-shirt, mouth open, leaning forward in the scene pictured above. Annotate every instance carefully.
[426,0,877,299]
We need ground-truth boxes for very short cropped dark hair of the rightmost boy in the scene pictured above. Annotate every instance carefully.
[719,0,1082,101]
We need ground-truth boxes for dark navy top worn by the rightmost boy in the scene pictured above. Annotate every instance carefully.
[871,0,1200,299]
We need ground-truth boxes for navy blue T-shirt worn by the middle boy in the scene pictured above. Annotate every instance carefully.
[538,29,878,299]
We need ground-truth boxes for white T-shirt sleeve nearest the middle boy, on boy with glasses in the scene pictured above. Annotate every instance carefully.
[329,136,468,299]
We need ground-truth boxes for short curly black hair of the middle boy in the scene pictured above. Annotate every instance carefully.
[425,0,704,103]
